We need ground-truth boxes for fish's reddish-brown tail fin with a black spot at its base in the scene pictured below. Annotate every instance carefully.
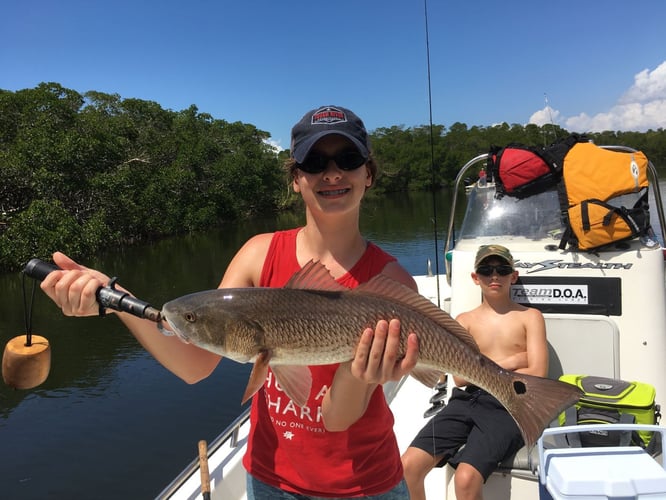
[506,373,582,448]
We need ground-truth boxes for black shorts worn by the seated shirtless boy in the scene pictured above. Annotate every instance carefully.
[411,387,524,481]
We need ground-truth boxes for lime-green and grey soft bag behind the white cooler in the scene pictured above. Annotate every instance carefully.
[559,374,661,448]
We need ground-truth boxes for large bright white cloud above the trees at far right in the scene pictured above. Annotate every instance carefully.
[529,61,666,132]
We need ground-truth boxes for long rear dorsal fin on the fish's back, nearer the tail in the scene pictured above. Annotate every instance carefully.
[349,274,479,352]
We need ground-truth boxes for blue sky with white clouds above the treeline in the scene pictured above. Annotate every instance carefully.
[0,0,666,147]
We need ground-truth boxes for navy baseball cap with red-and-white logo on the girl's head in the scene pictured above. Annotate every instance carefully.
[291,105,370,163]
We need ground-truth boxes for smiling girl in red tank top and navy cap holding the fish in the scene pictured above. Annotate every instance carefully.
[42,106,418,500]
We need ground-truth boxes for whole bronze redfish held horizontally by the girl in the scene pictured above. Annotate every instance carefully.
[162,263,581,446]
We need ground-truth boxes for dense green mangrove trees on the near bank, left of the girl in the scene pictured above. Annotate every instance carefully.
[0,83,282,271]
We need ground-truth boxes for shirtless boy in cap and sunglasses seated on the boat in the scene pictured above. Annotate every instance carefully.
[402,245,548,500]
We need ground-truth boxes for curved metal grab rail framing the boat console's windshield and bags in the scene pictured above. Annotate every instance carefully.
[444,145,666,285]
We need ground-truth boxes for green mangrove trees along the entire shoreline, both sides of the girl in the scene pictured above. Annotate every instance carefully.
[0,82,666,273]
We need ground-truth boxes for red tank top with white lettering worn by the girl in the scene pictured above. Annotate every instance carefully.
[243,229,403,497]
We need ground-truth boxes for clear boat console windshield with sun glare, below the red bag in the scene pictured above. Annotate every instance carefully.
[460,185,564,240]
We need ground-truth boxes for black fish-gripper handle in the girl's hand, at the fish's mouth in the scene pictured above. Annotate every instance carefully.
[23,259,162,323]
